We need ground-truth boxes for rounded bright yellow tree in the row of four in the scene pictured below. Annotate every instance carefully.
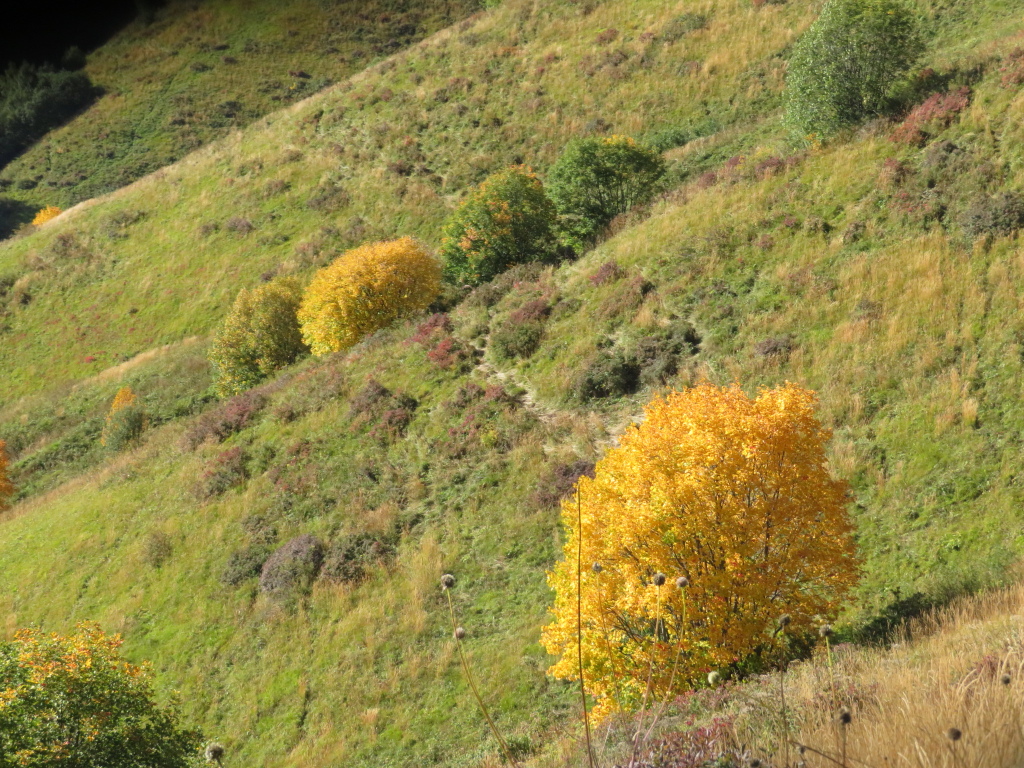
[299,238,440,355]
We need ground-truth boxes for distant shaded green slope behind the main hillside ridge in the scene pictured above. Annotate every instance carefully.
[0,0,478,218]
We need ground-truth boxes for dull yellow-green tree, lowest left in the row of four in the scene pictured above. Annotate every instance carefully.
[210,278,308,397]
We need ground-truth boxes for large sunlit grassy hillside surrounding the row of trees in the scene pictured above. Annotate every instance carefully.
[0,0,1024,765]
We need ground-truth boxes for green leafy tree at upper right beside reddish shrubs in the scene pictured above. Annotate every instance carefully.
[785,0,924,139]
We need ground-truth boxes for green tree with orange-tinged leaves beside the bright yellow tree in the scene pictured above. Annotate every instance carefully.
[441,166,556,286]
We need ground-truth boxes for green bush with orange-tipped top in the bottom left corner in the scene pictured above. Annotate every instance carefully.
[0,625,202,768]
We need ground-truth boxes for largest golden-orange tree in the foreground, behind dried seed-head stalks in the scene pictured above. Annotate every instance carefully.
[543,384,859,715]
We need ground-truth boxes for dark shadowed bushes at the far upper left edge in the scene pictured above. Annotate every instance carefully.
[0,63,99,165]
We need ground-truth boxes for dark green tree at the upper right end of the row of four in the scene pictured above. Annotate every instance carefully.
[548,136,665,250]
